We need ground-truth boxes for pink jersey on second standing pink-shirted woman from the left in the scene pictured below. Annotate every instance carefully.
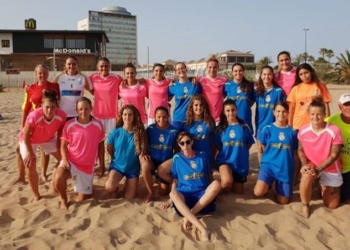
[119,83,147,124]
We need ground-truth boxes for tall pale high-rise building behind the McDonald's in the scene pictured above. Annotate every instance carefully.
[78,6,138,70]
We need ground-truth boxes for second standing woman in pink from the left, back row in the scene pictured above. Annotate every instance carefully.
[119,63,147,126]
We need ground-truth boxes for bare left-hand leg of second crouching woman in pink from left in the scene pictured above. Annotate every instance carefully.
[54,167,72,210]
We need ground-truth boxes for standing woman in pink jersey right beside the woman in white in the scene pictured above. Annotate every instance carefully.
[89,57,123,135]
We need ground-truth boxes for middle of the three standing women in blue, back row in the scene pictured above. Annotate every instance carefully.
[224,63,254,131]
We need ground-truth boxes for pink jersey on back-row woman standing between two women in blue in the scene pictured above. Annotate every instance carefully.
[198,76,227,122]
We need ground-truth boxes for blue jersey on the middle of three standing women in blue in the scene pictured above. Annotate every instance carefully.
[224,80,255,131]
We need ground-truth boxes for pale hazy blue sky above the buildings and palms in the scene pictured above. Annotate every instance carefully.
[0,0,350,65]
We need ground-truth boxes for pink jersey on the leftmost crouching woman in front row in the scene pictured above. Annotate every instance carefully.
[19,108,67,144]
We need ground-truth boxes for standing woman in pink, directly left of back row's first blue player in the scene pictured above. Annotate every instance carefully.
[146,63,170,125]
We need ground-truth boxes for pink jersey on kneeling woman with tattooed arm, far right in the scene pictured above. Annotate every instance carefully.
[298,123,343,173]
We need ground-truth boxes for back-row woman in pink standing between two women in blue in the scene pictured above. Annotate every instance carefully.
[198,55,228,124]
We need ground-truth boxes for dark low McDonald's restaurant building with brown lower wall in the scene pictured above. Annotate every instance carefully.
[0,29,108,73]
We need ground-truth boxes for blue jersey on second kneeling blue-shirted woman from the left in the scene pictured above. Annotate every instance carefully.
[146,123,178,165]
